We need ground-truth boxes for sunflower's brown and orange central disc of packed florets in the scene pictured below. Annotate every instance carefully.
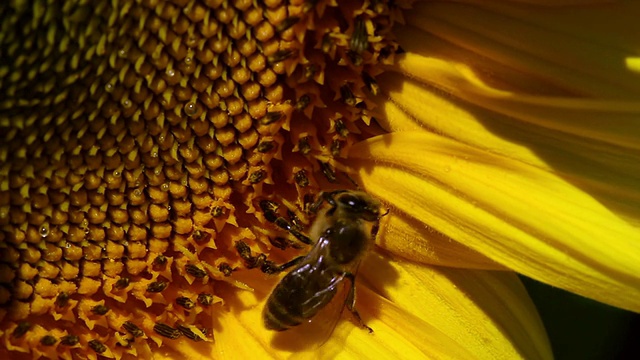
[0,0,406,358]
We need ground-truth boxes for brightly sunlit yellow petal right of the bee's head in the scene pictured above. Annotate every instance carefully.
[351,132,640,311]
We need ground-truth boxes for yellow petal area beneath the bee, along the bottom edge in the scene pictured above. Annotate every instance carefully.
[167,252,551,359]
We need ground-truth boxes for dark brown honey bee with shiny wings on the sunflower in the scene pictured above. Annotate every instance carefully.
[262,190,386,332]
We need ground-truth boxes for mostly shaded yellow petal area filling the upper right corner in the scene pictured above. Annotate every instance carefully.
[377,2,640,225]
